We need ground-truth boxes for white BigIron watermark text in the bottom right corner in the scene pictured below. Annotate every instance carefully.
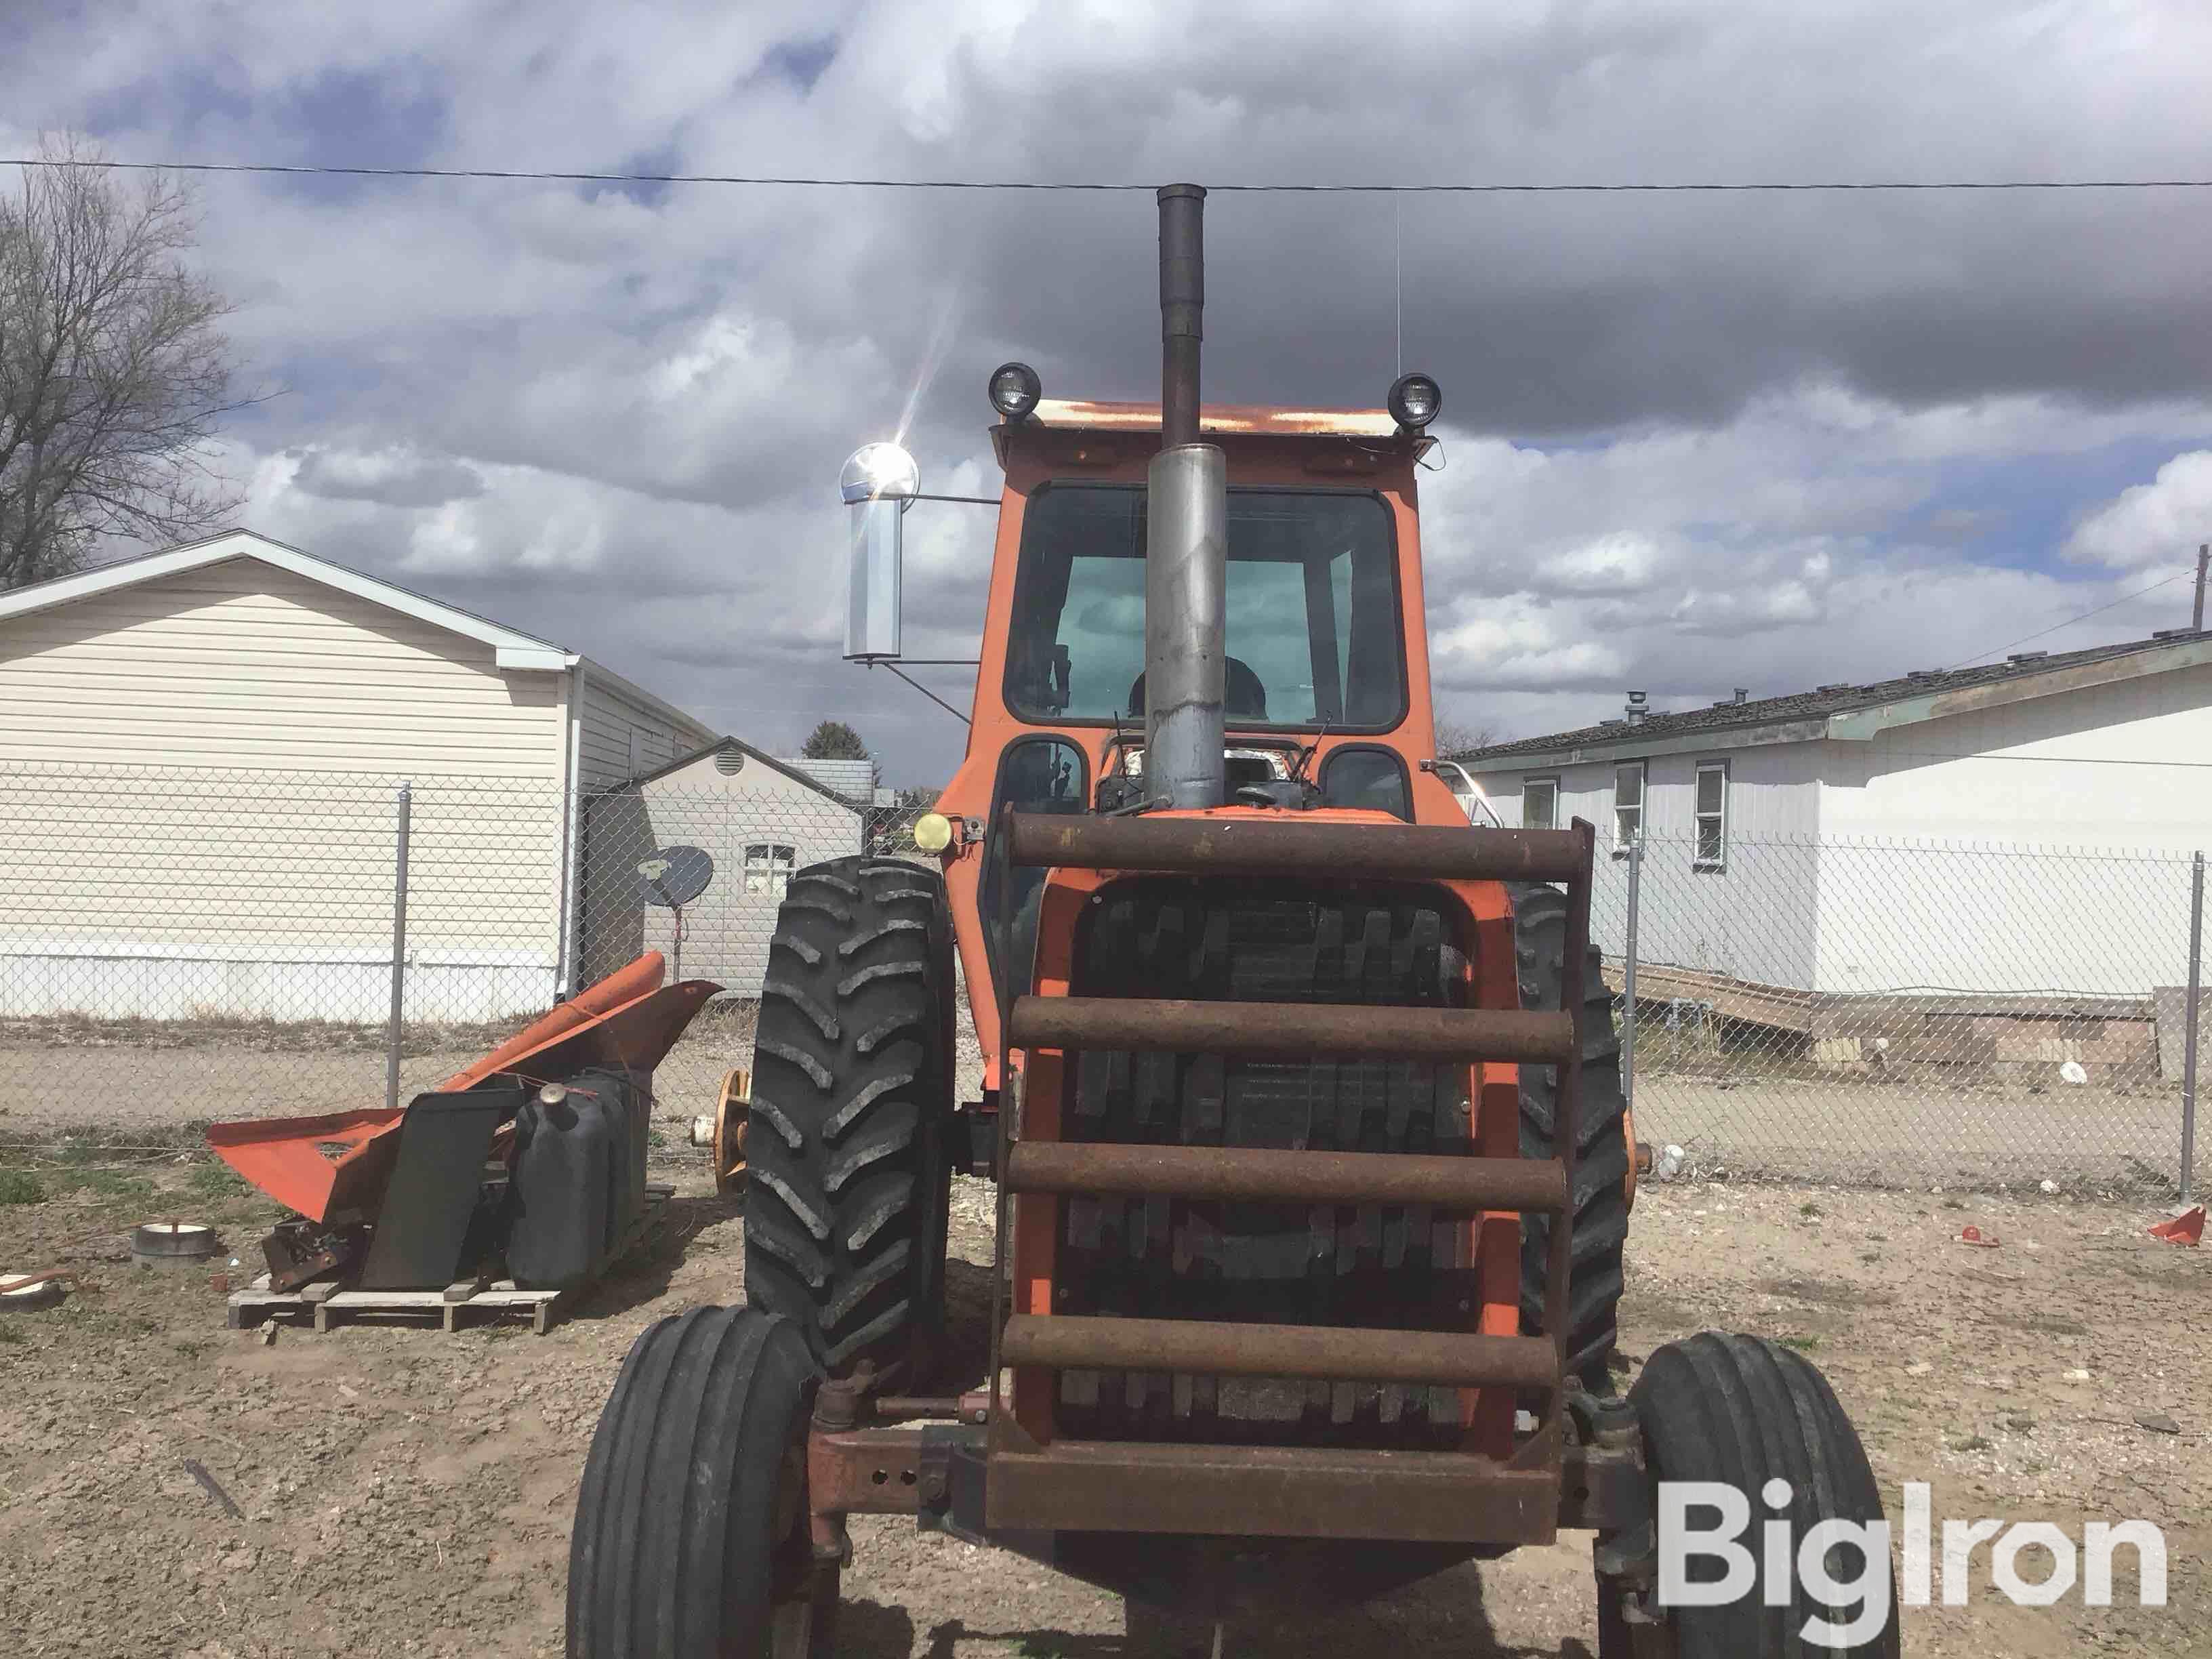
[1659,1480,2165,1648]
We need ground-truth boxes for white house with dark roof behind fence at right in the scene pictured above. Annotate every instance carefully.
[1453,630,2212,998]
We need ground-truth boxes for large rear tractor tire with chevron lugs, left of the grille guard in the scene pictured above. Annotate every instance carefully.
[745,856,956,1382]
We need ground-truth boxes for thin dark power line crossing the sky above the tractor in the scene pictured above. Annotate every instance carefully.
[0,157,2212,197]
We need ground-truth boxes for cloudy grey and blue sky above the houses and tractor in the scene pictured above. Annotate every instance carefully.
[0,0,2212,783]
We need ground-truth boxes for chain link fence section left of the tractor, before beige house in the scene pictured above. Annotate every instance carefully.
[0,763,920,1130]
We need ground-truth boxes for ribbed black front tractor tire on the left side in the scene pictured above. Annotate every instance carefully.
[569,1307,838,1659]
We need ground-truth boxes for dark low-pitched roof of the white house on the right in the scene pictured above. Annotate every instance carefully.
[1449,630,2212,772]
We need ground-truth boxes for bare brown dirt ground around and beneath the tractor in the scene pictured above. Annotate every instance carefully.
[0,1108,2212,1659]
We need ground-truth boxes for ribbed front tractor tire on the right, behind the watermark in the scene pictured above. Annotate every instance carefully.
[1597,1332,1898,1659]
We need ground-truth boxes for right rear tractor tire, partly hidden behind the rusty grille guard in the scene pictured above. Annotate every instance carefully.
[1507,882,1633,1393]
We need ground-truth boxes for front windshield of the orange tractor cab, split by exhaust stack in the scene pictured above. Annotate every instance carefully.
[1006,485,1405,732]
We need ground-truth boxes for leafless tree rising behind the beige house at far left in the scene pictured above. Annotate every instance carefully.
[0,140,254,590]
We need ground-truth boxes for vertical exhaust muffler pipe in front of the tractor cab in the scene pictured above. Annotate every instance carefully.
[1143,184,1230,807]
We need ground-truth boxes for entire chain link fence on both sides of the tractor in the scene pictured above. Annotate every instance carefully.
[0,761,2207,1188]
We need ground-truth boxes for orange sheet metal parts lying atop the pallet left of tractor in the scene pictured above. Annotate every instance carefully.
[208,951,721,1221]
